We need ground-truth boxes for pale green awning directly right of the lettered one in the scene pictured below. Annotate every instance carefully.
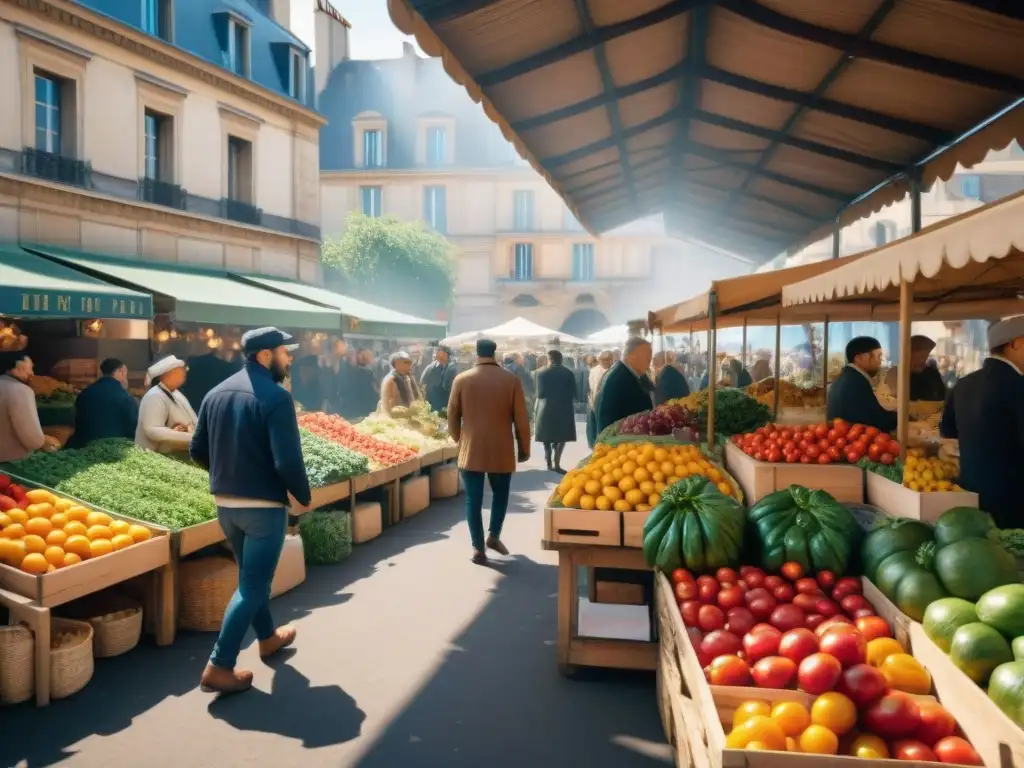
[27,246,341,331]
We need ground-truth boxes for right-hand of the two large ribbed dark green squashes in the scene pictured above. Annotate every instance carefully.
[749,485,861,573]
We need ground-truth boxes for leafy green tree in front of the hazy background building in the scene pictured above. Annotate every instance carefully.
[323,212,455,318]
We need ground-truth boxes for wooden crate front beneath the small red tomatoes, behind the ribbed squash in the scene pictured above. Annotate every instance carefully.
[725,442,864,505]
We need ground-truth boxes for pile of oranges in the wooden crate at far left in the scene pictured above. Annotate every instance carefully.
[0,488,153,574]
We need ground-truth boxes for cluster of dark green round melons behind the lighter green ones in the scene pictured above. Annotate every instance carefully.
[860,507,1019,618]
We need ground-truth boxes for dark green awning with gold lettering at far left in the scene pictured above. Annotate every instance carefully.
[0,244,153,321]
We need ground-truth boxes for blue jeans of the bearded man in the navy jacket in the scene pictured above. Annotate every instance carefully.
[210,507,288,670]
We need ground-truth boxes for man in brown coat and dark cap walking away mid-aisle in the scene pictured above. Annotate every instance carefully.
[447,339,529,564]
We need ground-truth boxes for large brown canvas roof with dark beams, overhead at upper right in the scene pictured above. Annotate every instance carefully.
[388,0,1024,260]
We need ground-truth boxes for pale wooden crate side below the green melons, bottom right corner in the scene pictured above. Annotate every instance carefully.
[910,622,1024,768]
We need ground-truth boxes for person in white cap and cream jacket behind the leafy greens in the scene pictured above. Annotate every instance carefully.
[135,354,199,454]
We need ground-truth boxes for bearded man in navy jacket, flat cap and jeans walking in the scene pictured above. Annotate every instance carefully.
[190,328,310,693]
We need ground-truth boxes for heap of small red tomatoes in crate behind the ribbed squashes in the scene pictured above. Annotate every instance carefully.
[731,419,902,464]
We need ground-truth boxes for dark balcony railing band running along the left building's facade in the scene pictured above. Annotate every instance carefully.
[0,146,321,241]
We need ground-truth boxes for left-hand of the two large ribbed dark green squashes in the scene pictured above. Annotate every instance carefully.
[643,474,746,571]
